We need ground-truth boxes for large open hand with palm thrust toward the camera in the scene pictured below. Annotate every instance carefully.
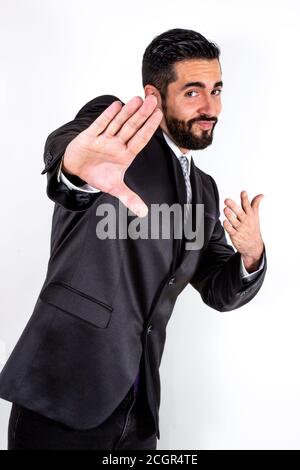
[62,95,163,217]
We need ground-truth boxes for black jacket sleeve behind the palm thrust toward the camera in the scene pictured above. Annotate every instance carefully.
[41,95,121,211]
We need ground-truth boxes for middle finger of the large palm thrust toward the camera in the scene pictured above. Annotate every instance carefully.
[116,95,161,144]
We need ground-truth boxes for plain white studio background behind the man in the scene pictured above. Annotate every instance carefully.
[0,0,300,449]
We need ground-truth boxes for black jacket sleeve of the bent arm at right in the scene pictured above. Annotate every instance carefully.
[190,174,267,312]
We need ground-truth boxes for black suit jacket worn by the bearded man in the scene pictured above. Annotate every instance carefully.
[0,95,267,438]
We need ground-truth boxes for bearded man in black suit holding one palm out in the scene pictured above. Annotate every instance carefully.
[0,29,267,449]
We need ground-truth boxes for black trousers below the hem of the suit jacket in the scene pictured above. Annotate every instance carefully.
[7,366,157,450]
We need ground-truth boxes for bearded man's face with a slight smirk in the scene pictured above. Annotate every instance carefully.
[156,59,222,153]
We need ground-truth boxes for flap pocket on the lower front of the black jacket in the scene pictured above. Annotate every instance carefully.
[40,281,113,328]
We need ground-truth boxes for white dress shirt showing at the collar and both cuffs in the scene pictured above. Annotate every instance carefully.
[57,130,265,281]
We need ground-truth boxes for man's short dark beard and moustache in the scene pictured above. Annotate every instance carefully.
[162,99,217,150]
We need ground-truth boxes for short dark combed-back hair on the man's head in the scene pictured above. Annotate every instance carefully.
[142,28,220,101]
